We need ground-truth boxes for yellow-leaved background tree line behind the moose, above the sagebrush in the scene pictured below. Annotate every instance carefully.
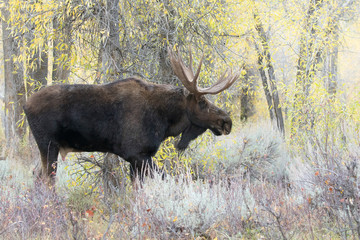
[1,0,359,156]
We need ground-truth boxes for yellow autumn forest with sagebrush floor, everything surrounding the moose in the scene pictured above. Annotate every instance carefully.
[0,0,360,239]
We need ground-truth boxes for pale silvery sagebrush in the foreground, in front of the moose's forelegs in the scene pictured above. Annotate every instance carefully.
[117,174,255,239]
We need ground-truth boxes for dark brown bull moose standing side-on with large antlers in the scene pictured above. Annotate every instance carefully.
[24,48,239,183]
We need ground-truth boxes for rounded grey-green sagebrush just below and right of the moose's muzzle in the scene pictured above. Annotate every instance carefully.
[192,124,290,186]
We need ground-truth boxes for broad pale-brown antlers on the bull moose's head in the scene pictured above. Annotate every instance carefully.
[168,47,240,96]
